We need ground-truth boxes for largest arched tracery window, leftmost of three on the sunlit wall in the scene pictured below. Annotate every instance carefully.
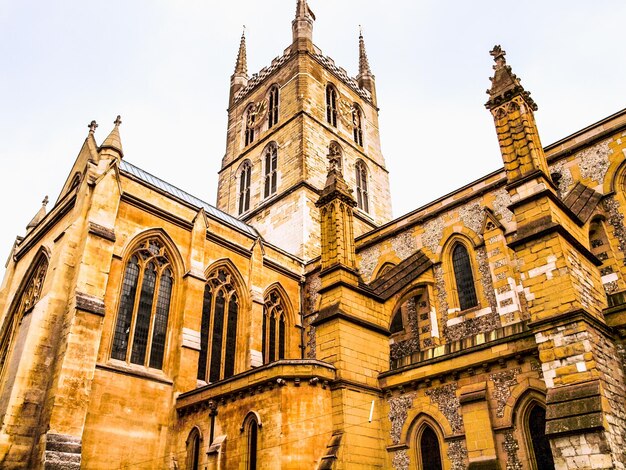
[111,238,174,369]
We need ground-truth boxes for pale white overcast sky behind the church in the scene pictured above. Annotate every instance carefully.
[0,0,626,276]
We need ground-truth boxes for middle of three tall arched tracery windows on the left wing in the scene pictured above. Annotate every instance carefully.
[198,268,239,382]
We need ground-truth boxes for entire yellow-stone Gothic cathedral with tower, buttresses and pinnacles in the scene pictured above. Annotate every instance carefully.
[0,0,626,470]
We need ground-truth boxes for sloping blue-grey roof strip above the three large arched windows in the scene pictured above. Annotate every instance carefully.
[120,160,259,238]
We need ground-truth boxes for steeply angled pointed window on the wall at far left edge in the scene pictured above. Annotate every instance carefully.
[0,253,48,377]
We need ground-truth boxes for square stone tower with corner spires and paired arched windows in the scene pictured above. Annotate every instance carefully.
[217,0,391,260]
